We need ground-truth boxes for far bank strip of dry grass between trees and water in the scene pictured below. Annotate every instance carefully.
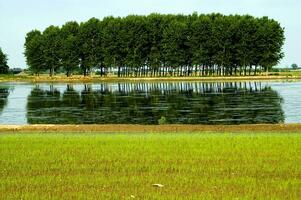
[0,72,301,83]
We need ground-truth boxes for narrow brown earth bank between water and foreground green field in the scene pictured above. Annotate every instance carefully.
[0,124,301,133]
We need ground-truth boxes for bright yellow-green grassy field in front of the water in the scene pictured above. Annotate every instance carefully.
[0,133,301,199]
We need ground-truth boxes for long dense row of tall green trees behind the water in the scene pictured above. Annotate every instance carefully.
[25,13,285,77]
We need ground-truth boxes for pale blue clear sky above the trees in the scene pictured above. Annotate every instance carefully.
[0,0,301,68]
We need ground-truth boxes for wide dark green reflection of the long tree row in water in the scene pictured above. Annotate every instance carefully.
[28,83,284,124]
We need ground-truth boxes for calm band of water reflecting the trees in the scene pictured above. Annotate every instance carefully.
[0,81,301,124]
